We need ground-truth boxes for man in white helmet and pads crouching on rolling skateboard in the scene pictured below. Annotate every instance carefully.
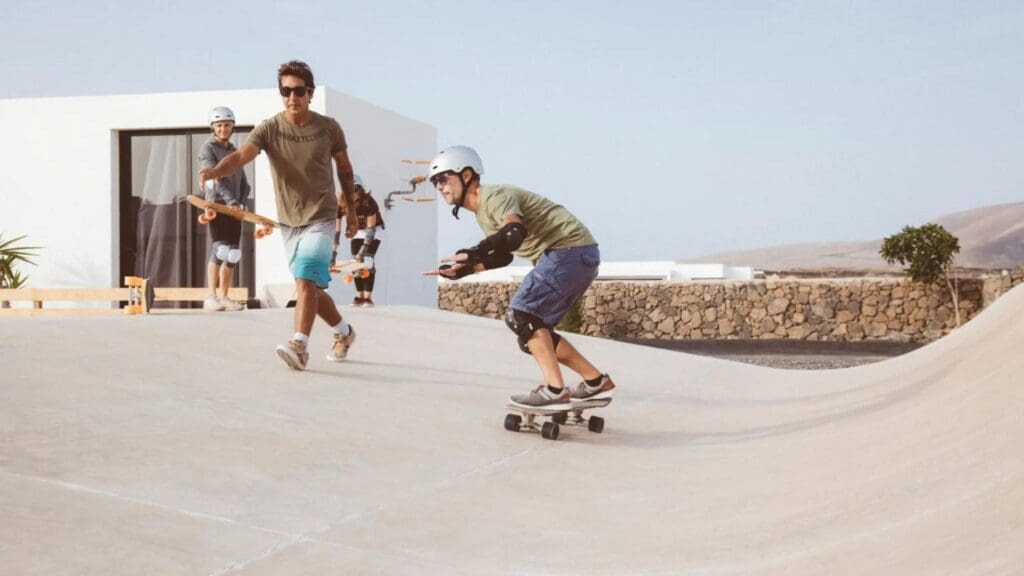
[424,146,615,410]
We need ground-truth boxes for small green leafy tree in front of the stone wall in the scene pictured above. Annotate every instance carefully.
[879,223,961,326]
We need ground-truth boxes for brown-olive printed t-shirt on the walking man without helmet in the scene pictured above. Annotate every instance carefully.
[247,112,347,227]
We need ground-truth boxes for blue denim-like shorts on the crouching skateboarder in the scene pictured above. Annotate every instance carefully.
[509,244,601,328]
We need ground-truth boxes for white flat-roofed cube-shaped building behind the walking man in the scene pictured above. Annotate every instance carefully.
[0,86,437,307]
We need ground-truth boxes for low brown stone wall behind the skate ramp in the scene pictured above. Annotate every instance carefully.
[438,270,1024,341]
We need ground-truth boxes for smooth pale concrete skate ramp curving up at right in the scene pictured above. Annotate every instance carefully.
[0,288,1024,575]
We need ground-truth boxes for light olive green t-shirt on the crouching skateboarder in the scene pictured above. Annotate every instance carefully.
[476,184,597,262]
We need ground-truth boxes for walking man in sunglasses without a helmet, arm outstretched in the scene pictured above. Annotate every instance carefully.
[200,60,355,370]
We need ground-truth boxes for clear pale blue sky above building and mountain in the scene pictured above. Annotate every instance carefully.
[0,0,1024,259]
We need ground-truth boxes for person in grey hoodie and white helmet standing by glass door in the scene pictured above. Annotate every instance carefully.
[199,106,251,311]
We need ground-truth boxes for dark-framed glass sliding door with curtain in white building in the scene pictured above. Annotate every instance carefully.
[120,125,256,307]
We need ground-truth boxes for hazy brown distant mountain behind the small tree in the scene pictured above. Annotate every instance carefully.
[699,202,1024,271]
